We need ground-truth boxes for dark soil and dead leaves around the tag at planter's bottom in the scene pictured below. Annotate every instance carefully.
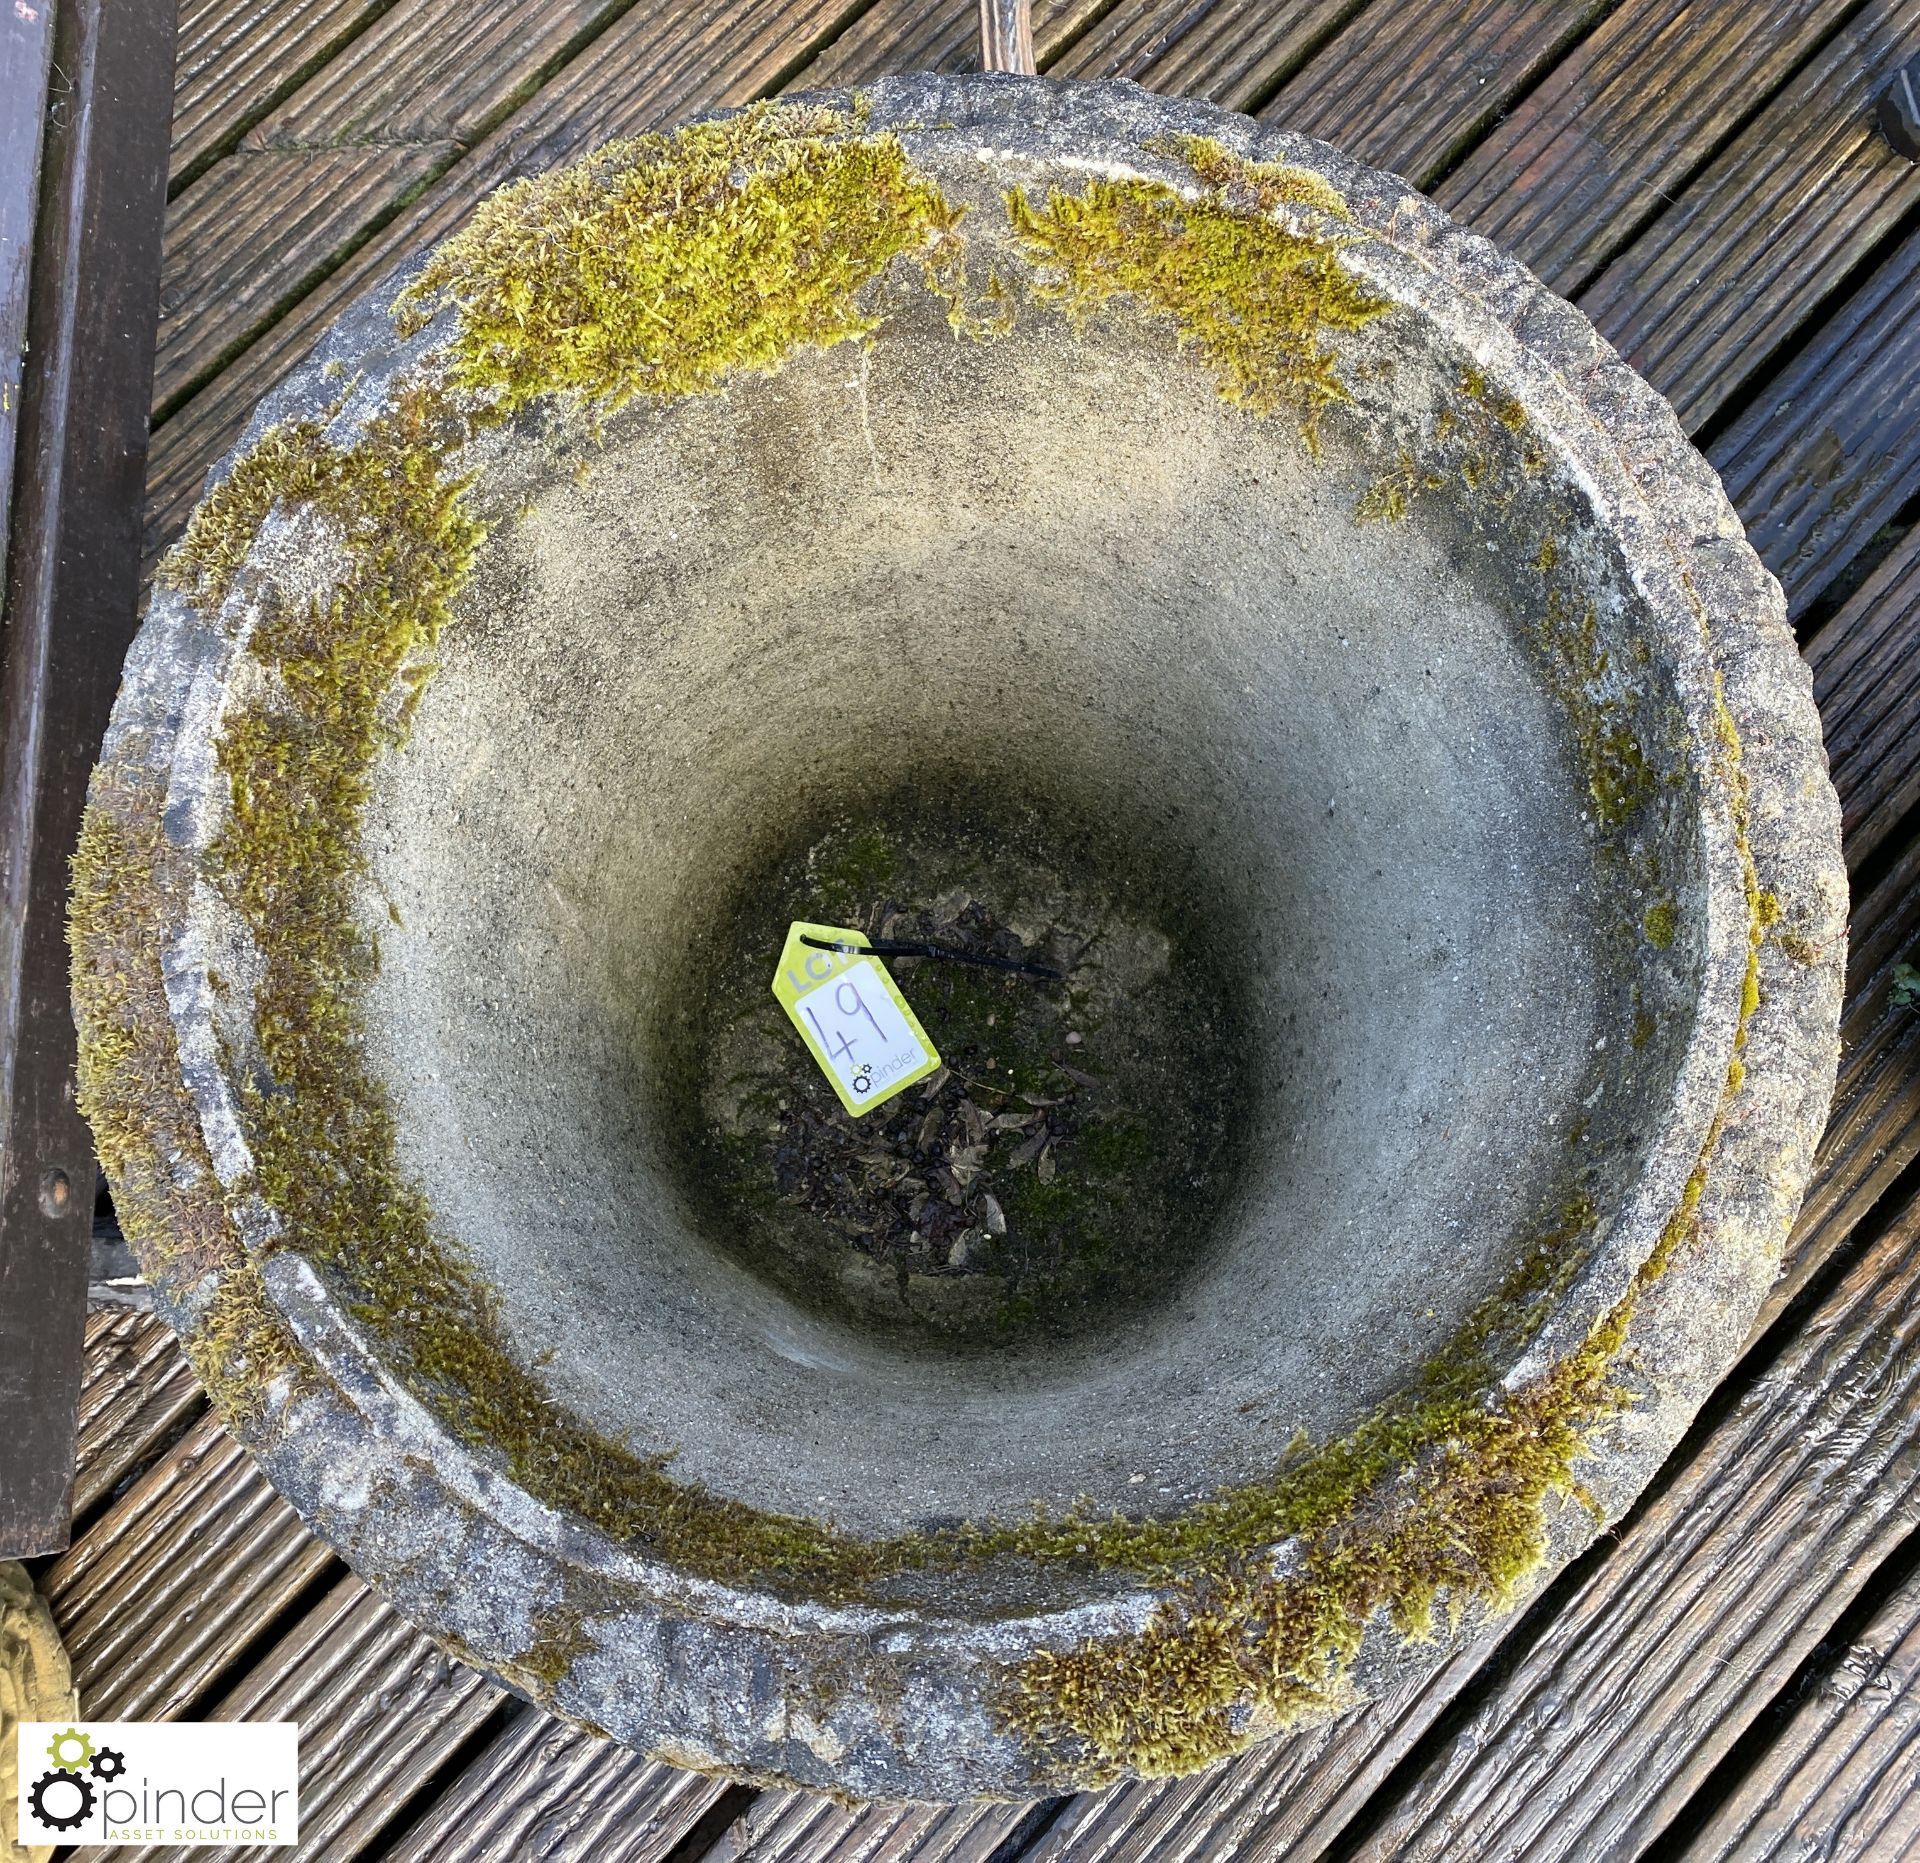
[672,806,1233,1343]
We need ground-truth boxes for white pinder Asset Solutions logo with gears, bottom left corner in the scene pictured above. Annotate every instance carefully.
[17,1721,300,1850]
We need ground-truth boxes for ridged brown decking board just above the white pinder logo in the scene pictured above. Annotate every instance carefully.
[40,1415,334,1721]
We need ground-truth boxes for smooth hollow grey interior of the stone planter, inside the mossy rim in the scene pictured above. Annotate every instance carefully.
[367,268,1703,1533]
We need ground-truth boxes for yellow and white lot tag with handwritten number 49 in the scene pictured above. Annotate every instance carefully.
[774,920,941,1118]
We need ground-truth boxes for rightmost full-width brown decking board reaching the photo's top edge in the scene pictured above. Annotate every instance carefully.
[1438,0,1857,294]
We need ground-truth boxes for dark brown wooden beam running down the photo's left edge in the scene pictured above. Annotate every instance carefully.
[0,0,173,1558]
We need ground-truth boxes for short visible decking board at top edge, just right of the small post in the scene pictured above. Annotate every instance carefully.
[1054,0,1367,109]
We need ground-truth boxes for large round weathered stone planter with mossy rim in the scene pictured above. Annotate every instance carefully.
[75,77,1845,1800]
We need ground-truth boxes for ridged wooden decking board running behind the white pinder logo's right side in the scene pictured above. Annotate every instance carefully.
[73,1573,505,1863]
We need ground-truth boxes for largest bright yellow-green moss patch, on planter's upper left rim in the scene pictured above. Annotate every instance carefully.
[396,104,960,411]
